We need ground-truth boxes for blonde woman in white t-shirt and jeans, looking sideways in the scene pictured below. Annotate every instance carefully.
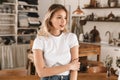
[32,4,80,80]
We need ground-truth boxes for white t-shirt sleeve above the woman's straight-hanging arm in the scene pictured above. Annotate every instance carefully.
[69,33,79,48]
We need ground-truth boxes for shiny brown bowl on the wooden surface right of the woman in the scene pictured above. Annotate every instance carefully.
[87,66,107,73]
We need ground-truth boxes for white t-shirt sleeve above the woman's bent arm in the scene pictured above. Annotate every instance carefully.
[32,37,44,50]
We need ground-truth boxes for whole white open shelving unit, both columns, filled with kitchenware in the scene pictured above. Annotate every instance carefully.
[0,0,41,45]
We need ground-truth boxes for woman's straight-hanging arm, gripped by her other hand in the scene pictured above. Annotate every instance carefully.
[70,46,80,80]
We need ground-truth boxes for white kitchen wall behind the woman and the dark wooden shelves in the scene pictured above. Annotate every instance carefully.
[38,0,120,42]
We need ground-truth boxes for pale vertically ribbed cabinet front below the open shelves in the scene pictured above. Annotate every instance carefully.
[0,44,30,69]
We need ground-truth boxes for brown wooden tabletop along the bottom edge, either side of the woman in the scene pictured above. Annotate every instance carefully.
[0,73,117,80]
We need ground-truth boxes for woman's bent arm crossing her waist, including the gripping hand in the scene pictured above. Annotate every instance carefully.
[33,49,79,77]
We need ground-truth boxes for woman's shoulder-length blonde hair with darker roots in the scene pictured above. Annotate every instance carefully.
[38,4,68,36]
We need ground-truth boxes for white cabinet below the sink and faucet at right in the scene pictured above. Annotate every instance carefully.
[100,45,120,69]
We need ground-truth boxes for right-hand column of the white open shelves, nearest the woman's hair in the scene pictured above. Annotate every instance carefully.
[17,0,41,44]
